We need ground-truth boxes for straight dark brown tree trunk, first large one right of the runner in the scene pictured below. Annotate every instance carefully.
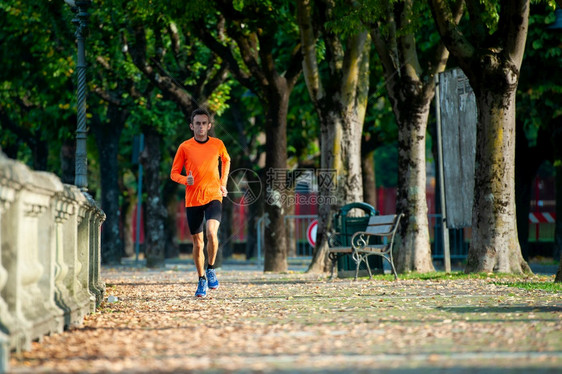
[264,89,290,272]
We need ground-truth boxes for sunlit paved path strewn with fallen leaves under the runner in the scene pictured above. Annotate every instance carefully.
[11,264,562,373]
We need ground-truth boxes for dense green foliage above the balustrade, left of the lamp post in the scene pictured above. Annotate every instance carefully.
[0,0,75,170]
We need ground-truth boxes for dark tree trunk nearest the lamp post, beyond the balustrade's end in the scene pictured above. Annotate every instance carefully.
[92,104,129,264]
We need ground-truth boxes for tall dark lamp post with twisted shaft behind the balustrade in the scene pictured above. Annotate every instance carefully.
[64,0,92,191]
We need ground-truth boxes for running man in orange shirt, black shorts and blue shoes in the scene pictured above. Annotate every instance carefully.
[170,109,230,297]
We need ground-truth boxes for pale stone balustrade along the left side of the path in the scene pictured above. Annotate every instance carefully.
[0,152,105,372]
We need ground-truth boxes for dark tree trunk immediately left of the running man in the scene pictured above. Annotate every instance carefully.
[141,126,168,268]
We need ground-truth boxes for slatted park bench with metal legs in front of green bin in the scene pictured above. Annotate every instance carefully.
[328,214,403,280]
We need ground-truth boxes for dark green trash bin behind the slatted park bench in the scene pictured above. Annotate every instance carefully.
[334,202,384,278]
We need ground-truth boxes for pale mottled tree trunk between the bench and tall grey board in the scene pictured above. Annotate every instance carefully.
[395,101,435,272]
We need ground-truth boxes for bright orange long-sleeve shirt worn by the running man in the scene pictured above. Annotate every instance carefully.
[170,137,230,207]
